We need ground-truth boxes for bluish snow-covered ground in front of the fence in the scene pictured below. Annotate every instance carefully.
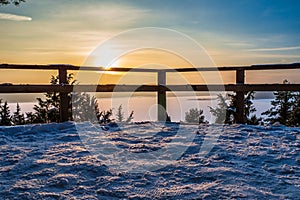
[0,122,300,199]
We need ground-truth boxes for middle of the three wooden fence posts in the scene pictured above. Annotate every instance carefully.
[157,71,167,121]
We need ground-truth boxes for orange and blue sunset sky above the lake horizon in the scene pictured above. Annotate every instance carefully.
[0,0,300,90]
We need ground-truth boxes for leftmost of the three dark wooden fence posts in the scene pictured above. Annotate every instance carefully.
[58,67,69,122]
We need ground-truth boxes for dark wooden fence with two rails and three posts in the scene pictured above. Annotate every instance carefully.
[0,63,300,123]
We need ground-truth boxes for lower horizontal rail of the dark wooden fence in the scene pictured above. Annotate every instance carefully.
[0,84,300,93]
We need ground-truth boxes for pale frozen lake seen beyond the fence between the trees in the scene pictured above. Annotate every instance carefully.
[3,96,271,122]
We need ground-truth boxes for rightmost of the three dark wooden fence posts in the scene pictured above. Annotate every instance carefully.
[236,69,245,124]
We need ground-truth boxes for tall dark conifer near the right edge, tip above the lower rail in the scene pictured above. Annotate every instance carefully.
[262,80,294,125]
